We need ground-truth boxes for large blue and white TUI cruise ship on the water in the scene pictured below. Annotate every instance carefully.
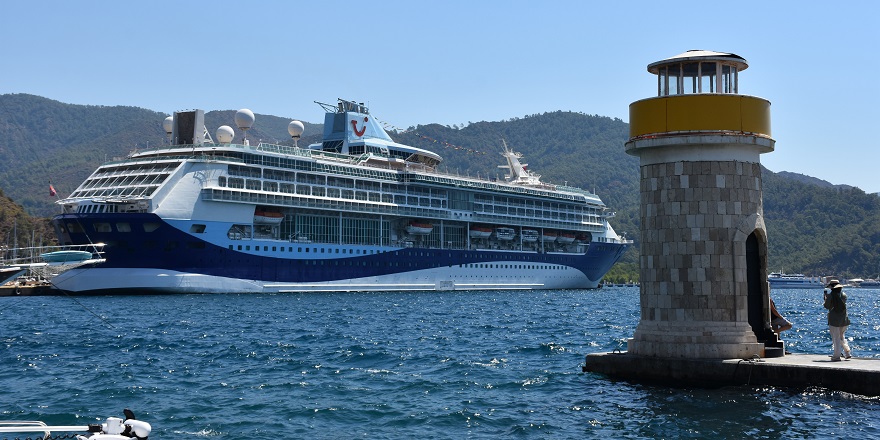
[53,99,632,294]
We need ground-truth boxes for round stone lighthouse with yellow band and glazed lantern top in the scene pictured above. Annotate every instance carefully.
[625,50,784,359]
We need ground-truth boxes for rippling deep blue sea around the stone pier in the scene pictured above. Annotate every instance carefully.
[0,288,880,439]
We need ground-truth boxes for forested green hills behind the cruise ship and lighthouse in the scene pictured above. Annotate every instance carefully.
[0,94,880,279]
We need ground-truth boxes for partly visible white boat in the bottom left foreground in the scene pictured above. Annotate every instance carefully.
[0,409,153,440]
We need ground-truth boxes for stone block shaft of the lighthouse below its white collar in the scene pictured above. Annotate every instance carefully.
[628,160,763,358]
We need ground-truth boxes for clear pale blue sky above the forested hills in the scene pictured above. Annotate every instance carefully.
[0,0,880,193]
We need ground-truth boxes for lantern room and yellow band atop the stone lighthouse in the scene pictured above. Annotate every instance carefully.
[628,50,772,146]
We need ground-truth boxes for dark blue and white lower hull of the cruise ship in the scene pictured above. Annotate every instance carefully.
[53,213,628,293]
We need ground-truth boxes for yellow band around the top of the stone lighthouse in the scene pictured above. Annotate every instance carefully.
[629,93,770,141]
